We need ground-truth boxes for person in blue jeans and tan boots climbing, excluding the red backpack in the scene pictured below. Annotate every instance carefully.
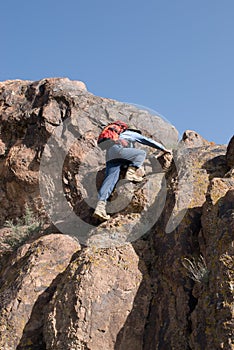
[93,123,171,221]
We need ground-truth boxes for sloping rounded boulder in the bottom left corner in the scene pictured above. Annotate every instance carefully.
[0,234,80,350]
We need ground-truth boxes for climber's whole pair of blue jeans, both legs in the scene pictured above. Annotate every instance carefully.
[98,145,146,201]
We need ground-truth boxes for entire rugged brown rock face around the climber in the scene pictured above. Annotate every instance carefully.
[0,78,234,350]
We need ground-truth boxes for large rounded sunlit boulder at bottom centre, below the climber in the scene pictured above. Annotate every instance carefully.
[44,244,150,350]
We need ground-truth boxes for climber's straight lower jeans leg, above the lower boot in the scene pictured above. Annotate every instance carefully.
[98,161,122,201]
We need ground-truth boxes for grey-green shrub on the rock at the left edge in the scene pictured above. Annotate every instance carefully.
[4,206,42,248]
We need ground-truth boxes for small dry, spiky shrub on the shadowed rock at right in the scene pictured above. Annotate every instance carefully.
[182,255,209,283]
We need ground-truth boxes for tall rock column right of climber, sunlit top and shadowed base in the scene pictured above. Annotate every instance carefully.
[139,145,230,350]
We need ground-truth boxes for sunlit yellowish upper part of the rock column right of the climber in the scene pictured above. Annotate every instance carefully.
[166,143,226,233]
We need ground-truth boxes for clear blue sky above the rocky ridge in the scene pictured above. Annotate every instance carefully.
[0,0,234,143]
